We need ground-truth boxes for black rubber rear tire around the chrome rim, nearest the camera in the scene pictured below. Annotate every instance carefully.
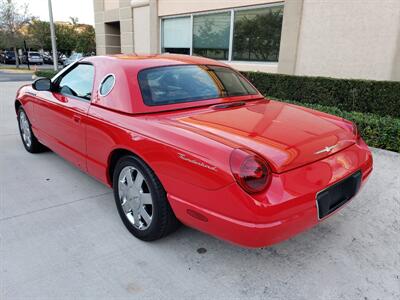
[113,155,180,241]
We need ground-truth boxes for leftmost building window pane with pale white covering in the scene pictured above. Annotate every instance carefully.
[162,17,192,54]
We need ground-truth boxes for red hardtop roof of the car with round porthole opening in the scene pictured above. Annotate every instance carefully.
[80,54,262,114]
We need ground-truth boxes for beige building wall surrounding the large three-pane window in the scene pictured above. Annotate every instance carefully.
[94,0,400,81]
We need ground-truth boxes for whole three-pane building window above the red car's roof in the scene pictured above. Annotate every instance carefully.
[161,3,283,62]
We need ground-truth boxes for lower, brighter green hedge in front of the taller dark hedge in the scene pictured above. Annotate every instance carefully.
[283,100,400,152]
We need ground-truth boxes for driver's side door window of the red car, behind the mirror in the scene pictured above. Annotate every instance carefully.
[58,64,94,100]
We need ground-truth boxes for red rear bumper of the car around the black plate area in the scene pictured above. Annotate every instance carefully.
[168,141,372,247]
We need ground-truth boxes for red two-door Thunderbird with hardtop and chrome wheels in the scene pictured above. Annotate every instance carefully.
[15,55,372,247]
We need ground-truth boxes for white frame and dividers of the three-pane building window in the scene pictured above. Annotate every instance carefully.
[159,1,285,65]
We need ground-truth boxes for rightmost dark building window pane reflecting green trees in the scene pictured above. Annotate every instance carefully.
[232,6,283,62]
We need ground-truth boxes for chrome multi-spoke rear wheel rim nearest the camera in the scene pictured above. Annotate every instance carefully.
[118,166,153,230]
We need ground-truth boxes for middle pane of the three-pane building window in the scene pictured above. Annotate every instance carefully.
[193,12,231,60]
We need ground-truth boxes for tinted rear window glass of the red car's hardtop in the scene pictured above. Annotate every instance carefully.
[138,65,258,106]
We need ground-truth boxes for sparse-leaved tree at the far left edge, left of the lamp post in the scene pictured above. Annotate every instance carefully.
[0,0,31,67]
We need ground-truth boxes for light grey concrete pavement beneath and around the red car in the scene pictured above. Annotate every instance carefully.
[0,82,400,299]
